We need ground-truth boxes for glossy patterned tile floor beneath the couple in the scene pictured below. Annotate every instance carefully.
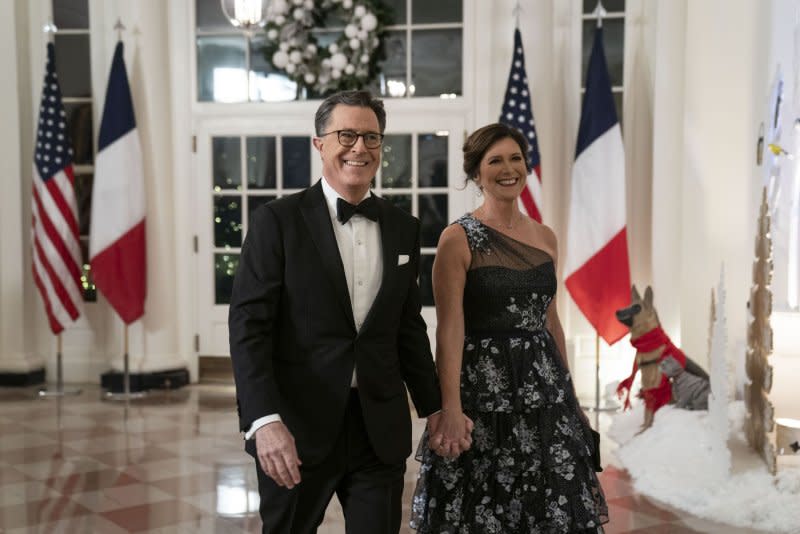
[0,386,758,534]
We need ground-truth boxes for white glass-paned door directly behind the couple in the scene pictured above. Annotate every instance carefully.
[196,112,472,356]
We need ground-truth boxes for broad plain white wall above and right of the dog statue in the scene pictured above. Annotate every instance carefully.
[677,0,769,364]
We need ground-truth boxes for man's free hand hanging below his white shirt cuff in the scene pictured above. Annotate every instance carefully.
[255,421,303,489]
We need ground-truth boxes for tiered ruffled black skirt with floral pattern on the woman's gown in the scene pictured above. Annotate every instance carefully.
[411,330,608,534]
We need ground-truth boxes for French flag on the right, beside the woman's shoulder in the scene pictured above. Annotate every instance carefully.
[564,28,631,345]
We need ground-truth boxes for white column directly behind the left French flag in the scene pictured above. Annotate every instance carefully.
[97,0,189,373]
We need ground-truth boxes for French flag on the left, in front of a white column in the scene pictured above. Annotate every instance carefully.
[89,42,147,324]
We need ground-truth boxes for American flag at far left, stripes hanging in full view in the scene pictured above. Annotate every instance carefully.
[31,43,83,334]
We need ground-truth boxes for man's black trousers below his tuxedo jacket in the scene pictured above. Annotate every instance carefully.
[256,389,406,534]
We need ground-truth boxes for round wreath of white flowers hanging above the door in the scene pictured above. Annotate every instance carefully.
[264,0,385,94]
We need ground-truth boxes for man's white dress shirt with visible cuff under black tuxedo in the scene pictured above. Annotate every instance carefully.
[244,176,383,439]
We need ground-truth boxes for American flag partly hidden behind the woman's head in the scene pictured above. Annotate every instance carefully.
[500,28,542,222]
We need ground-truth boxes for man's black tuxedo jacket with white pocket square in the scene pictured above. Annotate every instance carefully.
[228,182,441,466]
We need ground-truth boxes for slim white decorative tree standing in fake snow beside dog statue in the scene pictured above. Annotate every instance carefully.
[708,265,732,478]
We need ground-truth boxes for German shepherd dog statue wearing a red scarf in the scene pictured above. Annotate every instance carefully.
[616,285,709,430]
